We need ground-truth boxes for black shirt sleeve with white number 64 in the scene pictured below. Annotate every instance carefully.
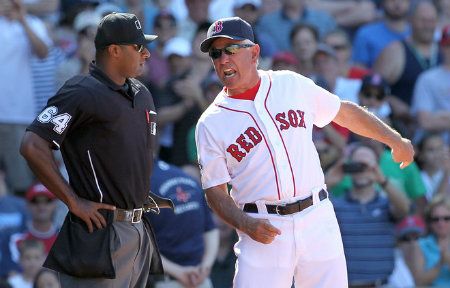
[27,81,94,149]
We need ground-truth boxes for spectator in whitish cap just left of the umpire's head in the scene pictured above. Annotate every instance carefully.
[52,10,101,88]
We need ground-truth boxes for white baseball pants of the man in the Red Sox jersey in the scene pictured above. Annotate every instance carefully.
[234,195,348,288]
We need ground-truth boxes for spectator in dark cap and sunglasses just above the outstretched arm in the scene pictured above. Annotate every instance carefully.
[359,74,392,124]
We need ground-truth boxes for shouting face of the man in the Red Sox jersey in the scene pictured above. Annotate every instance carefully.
[210,38,259,95]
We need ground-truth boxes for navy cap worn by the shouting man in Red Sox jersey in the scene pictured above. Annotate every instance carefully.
[200,17,255,53]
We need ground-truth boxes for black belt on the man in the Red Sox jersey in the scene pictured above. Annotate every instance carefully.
[244,189,328,215]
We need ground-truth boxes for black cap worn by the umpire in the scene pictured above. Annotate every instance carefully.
[95,12,158,49]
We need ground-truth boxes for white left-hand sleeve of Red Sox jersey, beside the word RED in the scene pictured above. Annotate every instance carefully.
[195,120,231,189]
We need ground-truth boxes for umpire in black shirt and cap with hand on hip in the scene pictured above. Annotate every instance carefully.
[21,13,162,287]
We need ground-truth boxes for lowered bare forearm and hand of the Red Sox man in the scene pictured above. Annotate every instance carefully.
[206,184,281,244]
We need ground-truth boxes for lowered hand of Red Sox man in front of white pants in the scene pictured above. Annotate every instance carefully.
[242,217,281,244]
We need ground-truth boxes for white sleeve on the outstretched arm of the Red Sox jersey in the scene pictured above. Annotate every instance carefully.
[306,79,341,127]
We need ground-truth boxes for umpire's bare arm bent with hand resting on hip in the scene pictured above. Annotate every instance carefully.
[20,131,115,232]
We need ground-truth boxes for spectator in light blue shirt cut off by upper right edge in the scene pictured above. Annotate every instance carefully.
[412,25,450,144]
